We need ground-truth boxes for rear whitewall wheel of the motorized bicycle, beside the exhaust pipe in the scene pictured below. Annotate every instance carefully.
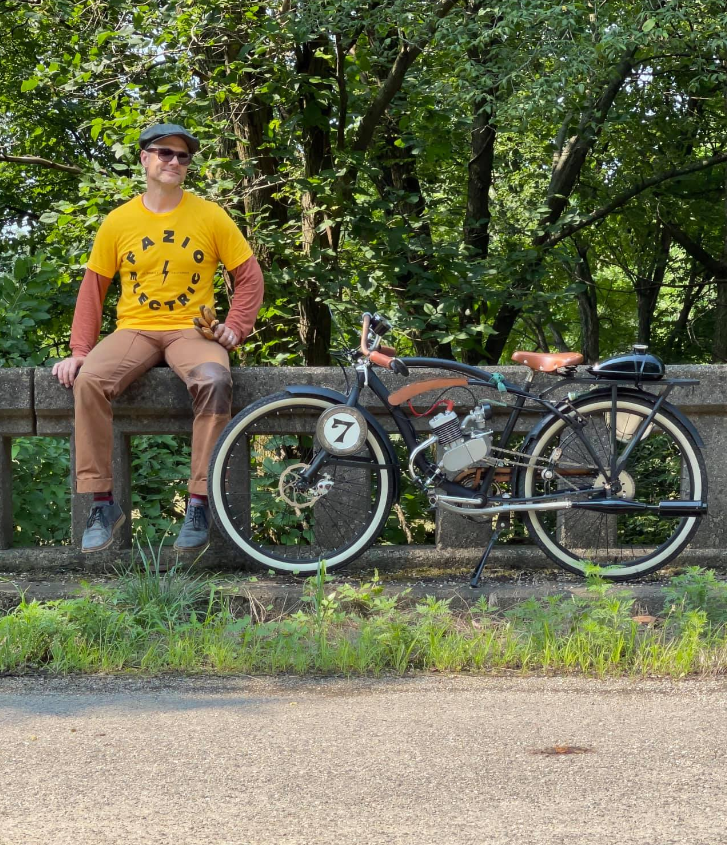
[519,396,707,581]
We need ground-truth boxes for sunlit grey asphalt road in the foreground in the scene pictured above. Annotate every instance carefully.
[0,676,727,845]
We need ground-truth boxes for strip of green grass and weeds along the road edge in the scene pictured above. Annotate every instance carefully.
[0,554,727,677]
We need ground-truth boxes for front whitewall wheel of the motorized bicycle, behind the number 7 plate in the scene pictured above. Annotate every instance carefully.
[208,393,396,574]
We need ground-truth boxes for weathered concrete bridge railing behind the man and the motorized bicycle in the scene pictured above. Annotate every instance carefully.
[0,366,727,571]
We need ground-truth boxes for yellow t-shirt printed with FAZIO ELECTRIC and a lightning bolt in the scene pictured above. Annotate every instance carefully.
[88,191,252,331]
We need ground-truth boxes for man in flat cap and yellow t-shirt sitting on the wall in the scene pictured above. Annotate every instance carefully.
[53,124,263,552]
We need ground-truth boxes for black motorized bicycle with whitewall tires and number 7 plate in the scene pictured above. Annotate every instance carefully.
[209,313,707,586]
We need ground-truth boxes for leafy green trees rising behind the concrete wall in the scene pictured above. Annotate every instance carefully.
[0,0,727,366]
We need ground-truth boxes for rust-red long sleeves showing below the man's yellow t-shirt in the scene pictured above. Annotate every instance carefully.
[70,256,264,358]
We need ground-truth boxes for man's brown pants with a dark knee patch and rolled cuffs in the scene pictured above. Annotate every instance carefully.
[73,329,232,495]
